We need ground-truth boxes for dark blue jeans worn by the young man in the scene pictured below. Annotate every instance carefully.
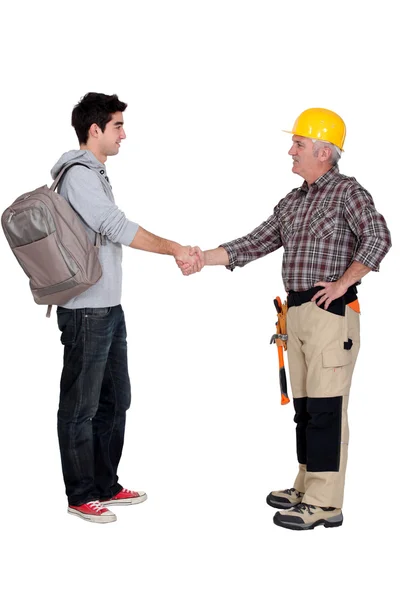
[57,305,131,506]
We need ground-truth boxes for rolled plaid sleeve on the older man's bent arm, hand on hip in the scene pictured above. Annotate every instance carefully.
[345,187,392,271]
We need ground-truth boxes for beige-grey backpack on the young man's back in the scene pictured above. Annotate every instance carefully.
[1,163,102,317]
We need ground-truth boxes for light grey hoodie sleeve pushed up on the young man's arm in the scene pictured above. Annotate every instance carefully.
[63,166,139,246]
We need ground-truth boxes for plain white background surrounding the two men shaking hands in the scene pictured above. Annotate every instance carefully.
[0,0,400,600]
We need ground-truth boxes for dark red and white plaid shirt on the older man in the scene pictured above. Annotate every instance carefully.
[221,166,391,292]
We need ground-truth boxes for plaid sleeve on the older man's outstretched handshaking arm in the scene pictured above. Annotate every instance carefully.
[220,209,282,271]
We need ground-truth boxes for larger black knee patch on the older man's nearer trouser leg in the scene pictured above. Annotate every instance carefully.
[306,396,342,472]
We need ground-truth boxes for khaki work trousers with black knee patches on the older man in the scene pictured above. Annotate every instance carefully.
[287,302,360,508]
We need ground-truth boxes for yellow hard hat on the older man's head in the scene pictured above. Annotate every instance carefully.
[285,108,346,150]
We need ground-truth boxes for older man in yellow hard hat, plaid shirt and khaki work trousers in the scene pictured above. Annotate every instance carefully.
[178,108,391,529]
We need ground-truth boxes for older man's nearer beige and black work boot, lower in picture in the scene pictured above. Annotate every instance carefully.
[274,502,343,529]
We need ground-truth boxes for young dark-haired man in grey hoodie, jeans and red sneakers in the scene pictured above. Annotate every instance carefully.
[51,93,203,523]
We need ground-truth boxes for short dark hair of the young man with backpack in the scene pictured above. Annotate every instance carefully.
[71,92,128,144]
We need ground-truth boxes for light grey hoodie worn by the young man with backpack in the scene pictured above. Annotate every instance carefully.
[51,150,139,308]
